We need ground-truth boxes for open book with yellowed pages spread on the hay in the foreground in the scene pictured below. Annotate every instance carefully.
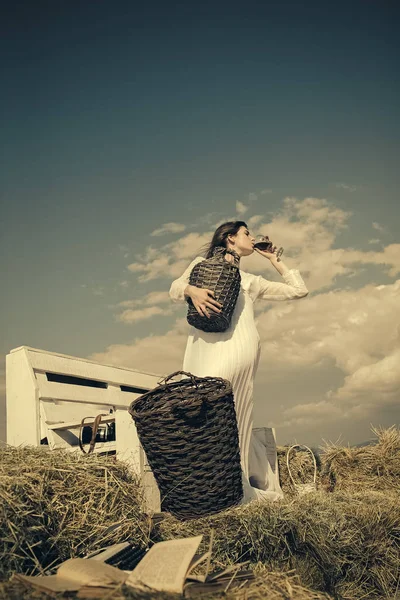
[15,532,252,598]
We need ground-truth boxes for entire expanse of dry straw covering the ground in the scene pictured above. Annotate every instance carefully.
[0,427,400,600]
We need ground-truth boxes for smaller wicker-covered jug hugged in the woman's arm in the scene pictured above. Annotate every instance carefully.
[187,246,241,333]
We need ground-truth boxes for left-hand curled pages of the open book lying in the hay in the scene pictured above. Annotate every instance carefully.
[15,558,128,592]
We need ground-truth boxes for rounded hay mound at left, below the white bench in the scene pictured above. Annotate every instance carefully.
[0,446,149,578]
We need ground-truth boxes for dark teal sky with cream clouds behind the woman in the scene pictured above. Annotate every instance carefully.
[0,0,400,446]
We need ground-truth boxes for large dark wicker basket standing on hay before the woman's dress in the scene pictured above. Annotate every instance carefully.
[129,371,243,519]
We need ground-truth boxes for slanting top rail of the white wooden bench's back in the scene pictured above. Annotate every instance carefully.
[10,346,162,390]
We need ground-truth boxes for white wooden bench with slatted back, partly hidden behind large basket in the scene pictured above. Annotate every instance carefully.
[6,346,161,511]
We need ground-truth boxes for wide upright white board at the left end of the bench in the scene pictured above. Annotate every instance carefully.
[6,351,40,446]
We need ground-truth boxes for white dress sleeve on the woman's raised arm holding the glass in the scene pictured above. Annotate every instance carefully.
[252,269,308,300]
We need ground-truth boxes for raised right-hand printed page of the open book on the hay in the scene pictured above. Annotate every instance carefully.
[125,535,203,594]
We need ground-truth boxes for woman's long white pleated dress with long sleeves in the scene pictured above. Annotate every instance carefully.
[170,256,308,503]
